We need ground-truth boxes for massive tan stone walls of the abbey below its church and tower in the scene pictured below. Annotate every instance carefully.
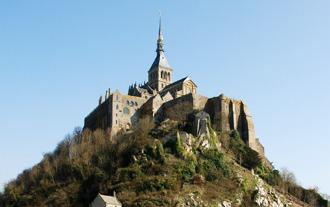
[85,88,264,155]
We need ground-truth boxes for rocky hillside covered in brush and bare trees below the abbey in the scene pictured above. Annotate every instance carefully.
[0,115,327,207]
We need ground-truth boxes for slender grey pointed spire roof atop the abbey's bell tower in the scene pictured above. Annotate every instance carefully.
[149,18,171,71]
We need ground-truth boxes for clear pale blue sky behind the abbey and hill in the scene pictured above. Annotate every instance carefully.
[0,0,330,194]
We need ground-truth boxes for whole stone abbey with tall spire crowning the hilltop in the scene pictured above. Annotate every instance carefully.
[84,22,264,155]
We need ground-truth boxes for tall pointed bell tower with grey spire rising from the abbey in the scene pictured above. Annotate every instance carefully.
[148,19,173,91]
